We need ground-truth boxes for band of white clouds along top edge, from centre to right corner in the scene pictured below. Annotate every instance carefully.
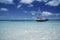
[20,0,60,6]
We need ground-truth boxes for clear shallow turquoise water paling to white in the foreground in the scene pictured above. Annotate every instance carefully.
[0,21,60,40]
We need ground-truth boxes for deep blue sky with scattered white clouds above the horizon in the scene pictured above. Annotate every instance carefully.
[0,0,60,20]
